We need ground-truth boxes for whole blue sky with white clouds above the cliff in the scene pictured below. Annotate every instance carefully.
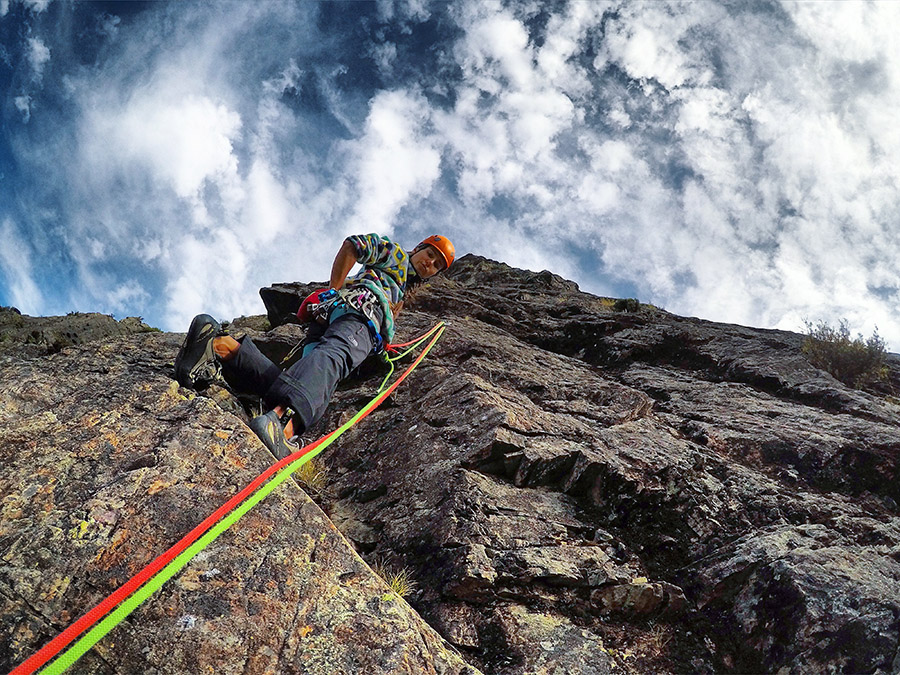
[0,0,900,351]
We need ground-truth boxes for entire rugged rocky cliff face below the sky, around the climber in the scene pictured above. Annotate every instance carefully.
[0,256,900,675]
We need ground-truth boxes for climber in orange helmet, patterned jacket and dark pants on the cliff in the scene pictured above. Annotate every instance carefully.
[175,234,456,459]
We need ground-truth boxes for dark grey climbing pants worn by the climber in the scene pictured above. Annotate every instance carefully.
[222,313,374,434]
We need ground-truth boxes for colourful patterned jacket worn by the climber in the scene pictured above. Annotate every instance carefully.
[347,234,409,342]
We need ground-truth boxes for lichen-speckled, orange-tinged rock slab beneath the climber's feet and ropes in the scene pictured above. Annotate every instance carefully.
[0,334,473,673]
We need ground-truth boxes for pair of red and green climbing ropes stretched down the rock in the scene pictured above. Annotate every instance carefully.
[10,322,446,675]
